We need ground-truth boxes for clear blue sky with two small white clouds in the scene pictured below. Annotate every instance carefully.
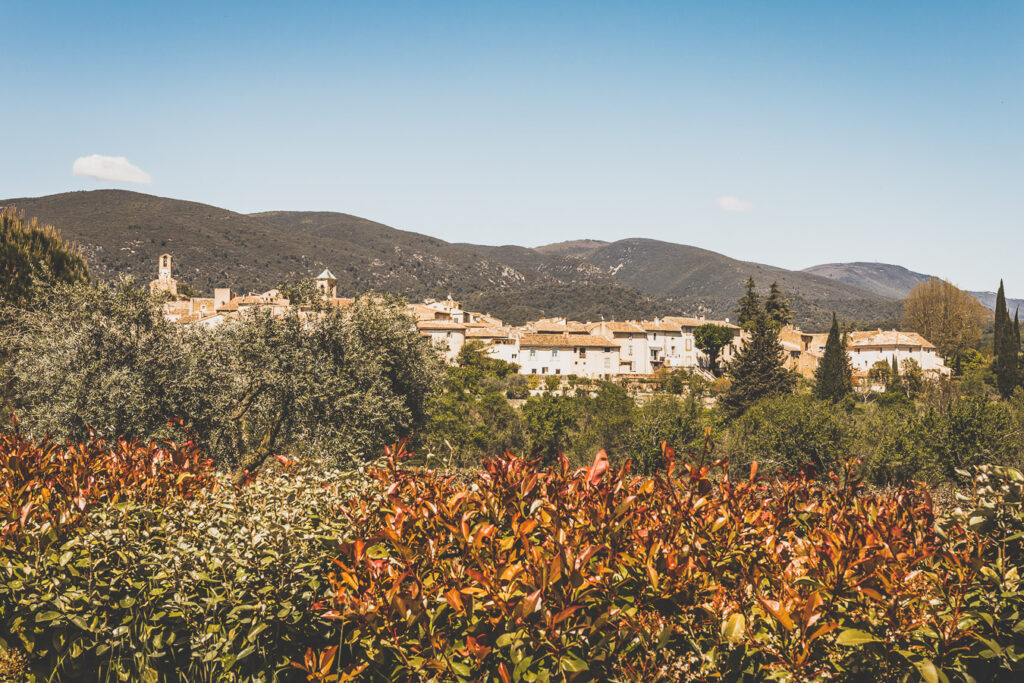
[0,0,1024,296]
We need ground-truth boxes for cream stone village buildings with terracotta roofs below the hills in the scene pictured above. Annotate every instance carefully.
[150,254,949,388]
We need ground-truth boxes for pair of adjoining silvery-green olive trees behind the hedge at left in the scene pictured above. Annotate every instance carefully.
[3,281,440,469]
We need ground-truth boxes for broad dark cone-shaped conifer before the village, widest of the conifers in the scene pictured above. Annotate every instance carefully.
[721,308,796,417]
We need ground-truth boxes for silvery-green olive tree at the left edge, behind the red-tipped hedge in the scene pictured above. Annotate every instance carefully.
[0,280,208,440]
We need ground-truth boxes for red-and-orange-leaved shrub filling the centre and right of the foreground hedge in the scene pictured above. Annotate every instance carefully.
[309,451,1024,683]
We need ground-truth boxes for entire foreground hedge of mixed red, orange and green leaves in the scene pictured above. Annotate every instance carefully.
[0,434,1024,683]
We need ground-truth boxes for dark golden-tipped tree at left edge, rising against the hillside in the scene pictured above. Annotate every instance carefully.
[0,207,89,306]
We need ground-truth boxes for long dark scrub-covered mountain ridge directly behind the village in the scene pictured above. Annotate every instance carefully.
[0,189,900,330]
